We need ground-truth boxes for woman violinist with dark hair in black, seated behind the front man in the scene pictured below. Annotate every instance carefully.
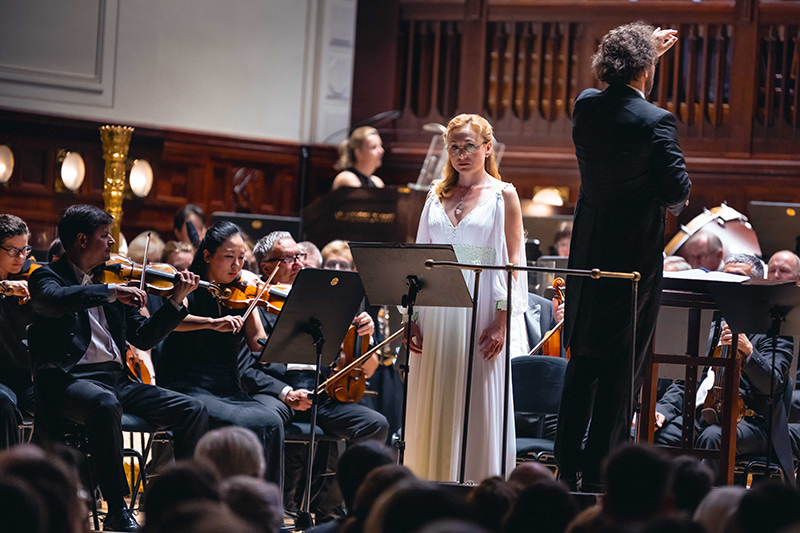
[158,221,290,486]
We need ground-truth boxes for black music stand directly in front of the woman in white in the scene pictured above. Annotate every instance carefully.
[350,242,479,482]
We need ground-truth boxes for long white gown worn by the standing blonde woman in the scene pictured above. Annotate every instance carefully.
[404,184,527,483]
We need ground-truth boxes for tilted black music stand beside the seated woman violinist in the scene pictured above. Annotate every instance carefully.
[260,268,364,529]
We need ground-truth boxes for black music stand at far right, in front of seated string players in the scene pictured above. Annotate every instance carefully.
[708,279,800,475]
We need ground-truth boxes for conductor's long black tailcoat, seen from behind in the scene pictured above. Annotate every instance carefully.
[563,85,691,357]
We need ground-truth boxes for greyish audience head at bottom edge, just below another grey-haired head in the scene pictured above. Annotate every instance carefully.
[220,476,283,533]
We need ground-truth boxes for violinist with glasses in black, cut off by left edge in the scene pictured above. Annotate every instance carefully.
[0,214,34,450]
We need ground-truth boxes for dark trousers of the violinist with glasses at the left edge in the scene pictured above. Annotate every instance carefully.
[0,368,34,450]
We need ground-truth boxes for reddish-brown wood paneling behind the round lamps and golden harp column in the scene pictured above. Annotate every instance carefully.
[0,109,336,249]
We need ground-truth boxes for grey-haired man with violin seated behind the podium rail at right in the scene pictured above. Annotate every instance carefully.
[655,254,794,484]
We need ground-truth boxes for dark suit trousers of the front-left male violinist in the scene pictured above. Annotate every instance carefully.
[35,363,208,500]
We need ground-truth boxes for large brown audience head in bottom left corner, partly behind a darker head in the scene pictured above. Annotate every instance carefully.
[0,445,88,533]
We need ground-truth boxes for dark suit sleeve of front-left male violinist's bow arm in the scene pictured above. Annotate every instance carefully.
[29,268,108,318]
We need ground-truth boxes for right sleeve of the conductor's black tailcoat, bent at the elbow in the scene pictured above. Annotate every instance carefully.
[652,113,692,215]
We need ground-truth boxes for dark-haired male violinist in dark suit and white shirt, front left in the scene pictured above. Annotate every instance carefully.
[29,205,208,531]
